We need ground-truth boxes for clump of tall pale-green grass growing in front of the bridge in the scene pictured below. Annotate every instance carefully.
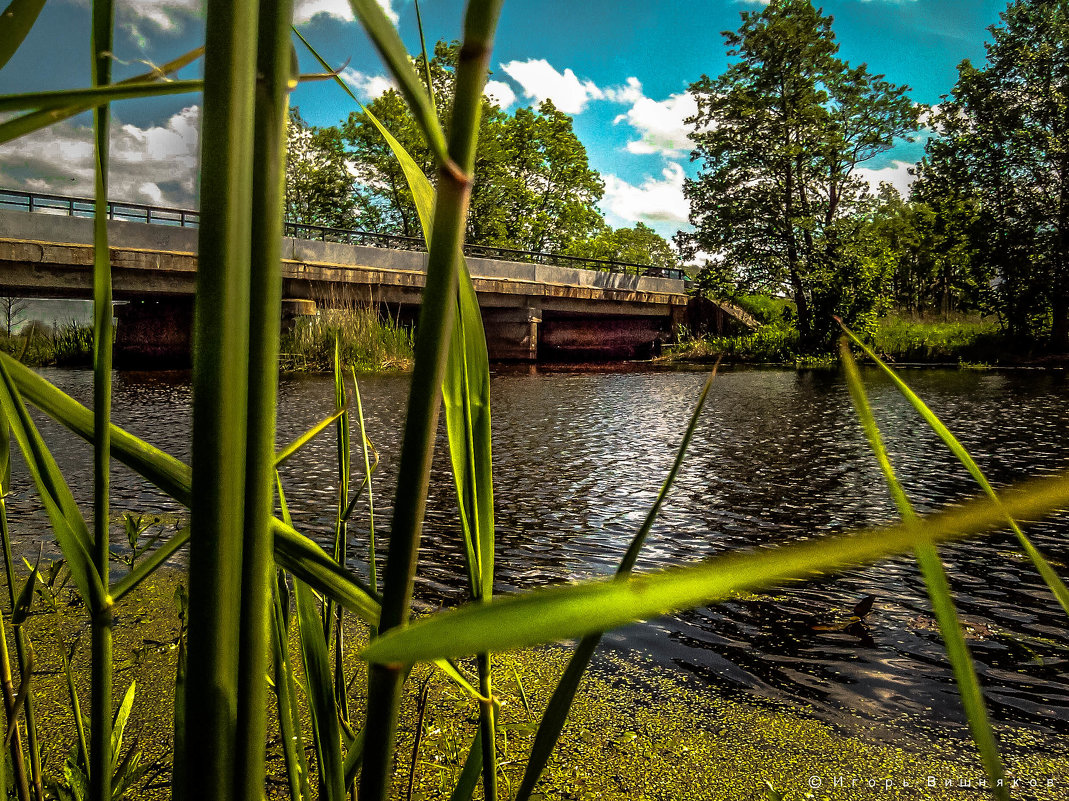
[279,307,413,372]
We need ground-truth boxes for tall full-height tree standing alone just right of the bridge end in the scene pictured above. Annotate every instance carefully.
[678,0,917,349]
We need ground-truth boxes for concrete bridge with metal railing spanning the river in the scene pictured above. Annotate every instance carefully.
[0,190,749,364]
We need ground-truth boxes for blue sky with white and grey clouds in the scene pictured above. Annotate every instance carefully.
[0,0,1006,236]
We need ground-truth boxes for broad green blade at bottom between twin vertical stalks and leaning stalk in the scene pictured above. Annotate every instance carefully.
[294,580,345,801]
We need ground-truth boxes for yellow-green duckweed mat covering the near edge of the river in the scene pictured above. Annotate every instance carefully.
[4,569,1069,801]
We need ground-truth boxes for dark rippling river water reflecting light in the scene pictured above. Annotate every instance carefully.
[12,370,1069,748]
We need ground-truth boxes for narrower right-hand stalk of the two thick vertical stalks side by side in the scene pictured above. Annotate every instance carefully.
[232,0,293,801]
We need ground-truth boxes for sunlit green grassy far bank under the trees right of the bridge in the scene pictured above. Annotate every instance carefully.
[659,315,1069,368]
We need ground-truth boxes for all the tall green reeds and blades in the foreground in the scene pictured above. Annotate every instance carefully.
[0,0,1069,801]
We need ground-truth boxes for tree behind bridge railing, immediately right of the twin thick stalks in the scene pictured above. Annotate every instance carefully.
[285,108,361,228]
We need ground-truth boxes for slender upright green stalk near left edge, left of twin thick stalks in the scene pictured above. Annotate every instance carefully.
[87,0,114,801]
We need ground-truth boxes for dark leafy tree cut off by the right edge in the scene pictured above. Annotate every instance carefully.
[927,0,1069,351]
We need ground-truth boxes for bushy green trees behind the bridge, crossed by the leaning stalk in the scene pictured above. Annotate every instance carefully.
[342,42,604,251]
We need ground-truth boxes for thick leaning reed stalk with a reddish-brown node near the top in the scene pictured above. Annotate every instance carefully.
[360,0,501,801]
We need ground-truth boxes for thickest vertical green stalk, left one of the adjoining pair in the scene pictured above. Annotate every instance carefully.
[184,0,259,801]
